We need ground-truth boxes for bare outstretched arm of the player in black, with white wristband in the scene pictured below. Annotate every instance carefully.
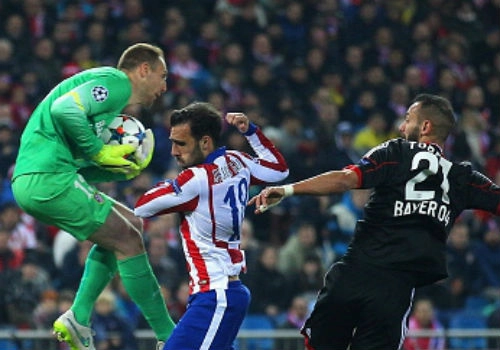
[248,167,359,214]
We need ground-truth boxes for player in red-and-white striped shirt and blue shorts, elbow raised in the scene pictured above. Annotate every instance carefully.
[135,102,288,350]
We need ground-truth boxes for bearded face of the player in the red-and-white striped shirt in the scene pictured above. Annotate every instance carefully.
[170,123,206,169]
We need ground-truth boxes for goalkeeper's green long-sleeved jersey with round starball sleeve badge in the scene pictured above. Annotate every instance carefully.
[14,67,132,181]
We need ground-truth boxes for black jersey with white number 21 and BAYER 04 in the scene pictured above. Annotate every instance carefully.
[344,139,500,286]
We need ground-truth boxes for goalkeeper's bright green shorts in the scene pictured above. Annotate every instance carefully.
[12,173,114,241]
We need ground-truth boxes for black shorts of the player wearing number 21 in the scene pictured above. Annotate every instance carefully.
[302,262,415,350]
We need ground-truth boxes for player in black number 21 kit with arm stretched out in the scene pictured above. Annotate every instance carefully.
[249,94,500,350]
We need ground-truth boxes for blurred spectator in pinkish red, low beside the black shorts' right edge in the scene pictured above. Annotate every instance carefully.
[403,299,445,350]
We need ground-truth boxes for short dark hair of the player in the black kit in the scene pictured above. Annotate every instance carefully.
[413,94,456,140]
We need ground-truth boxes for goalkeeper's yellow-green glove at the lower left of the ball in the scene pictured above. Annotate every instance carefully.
[92,144,140,174]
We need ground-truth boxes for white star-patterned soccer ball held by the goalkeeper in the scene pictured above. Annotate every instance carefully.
[100,114,146,160]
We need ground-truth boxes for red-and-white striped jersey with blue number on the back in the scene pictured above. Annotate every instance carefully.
[134,124,288,294]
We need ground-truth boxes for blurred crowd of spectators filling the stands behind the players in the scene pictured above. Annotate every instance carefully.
[0,0,500,350]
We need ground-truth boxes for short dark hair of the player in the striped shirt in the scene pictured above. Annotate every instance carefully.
[170,102,222,145]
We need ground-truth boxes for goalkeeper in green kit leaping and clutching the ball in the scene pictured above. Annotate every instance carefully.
[12,43,174,350]
